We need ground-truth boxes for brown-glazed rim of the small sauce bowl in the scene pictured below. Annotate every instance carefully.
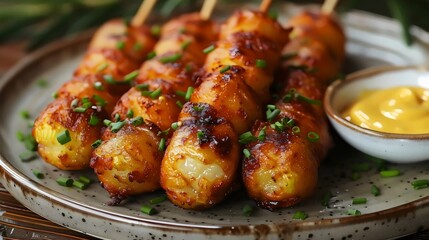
[323,65,429,140]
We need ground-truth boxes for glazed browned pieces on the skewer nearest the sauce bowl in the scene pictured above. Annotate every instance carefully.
[241,0,345,210]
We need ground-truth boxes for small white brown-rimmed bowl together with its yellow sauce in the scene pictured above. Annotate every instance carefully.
[323,66,429,163]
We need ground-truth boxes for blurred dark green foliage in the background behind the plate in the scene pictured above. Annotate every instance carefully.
[0,0,429,51]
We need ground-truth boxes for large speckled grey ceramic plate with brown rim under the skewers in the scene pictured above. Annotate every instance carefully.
[0,5,429,239]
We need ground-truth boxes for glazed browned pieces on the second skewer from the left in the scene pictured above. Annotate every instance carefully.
[91,1,218,204]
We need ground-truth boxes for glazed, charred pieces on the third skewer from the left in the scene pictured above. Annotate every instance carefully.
[161,0,288,209]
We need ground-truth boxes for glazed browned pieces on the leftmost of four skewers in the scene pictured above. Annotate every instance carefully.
[33,0,156,170]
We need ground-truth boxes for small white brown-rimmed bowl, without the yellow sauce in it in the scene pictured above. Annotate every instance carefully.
[323,66,429,163]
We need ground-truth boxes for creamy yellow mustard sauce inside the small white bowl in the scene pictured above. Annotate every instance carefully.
[342,87,429,134]
